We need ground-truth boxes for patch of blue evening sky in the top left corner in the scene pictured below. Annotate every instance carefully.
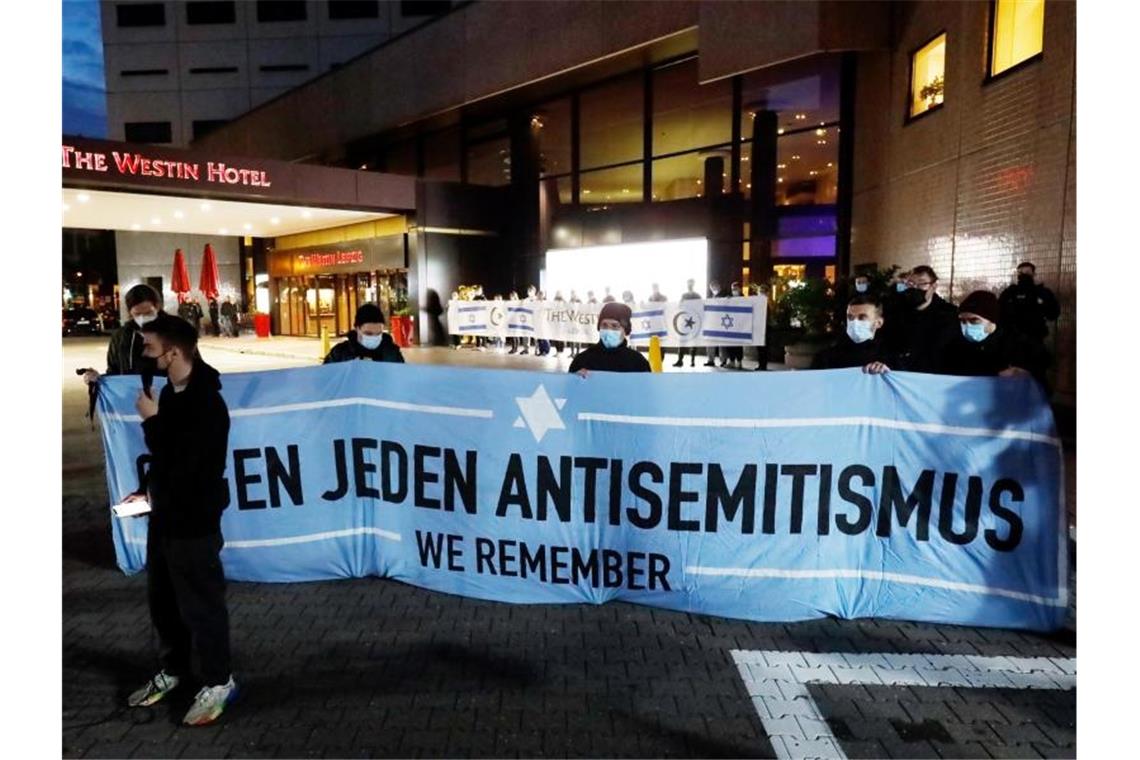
[63,0,107,138]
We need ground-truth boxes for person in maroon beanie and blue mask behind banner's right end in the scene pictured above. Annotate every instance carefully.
[942,291,1049,387]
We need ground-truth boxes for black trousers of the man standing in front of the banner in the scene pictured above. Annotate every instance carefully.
[146,530,231,686]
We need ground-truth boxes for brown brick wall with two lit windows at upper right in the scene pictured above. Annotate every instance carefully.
[852,0,1076,400]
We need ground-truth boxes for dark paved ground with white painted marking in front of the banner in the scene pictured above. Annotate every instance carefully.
[60,338,1076,758]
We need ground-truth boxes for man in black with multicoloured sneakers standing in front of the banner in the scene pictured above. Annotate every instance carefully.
[128,319,237,726]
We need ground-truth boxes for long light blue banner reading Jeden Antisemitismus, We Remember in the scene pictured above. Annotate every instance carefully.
[99,361,1067,630]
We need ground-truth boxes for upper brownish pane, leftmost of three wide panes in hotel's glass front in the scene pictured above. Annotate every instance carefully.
[579,72,645,169]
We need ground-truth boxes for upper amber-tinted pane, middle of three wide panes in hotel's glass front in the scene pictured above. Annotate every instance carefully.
[652,58,732,156]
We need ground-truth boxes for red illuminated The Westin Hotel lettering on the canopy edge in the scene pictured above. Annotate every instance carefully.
[62,145,272,188]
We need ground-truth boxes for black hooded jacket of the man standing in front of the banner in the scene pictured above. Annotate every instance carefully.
[139,357,229,538]
